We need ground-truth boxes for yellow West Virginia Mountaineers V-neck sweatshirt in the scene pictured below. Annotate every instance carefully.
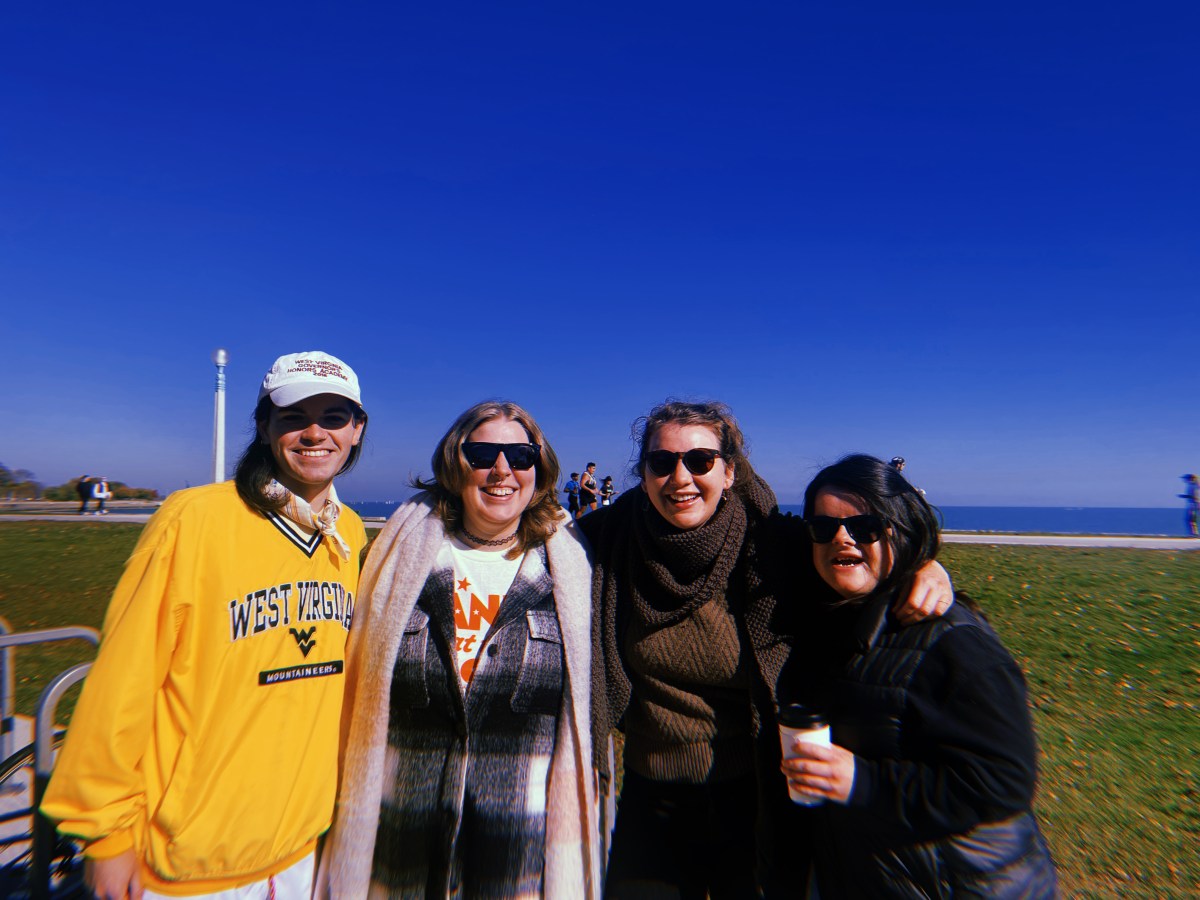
[42,482,366,895]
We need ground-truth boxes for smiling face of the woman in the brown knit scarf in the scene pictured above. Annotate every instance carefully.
[642,422,733,530]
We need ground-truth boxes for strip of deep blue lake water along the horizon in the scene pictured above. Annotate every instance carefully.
[347,500,1186,536]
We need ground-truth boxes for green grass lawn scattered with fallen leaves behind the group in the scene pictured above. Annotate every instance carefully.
[0,521,1200,898]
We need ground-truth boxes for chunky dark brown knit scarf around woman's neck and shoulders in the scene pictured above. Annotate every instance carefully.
[580,467,776,775]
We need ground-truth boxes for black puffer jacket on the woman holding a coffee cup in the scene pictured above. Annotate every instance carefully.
[797,596,1057,900]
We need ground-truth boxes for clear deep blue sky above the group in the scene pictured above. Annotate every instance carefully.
[0,1,1200,506]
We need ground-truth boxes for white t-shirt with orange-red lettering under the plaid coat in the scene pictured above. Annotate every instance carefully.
[437,538,524,691]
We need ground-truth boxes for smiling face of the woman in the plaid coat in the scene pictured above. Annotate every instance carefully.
[460,418,538,540]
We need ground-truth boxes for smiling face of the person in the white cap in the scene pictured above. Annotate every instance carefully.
[266,394,365,509]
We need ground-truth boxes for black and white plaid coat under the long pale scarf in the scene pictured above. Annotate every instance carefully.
[371,548,563,898]
